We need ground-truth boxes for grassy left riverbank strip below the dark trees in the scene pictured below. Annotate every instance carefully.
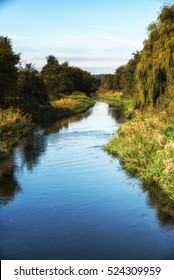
[0,94,95,159]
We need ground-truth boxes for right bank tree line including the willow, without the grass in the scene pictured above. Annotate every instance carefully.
[100,5,174,112]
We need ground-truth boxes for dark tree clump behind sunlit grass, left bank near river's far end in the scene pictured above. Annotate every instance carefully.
[42,56,98,100]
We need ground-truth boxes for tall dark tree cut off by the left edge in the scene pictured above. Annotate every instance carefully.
[0,36,20,104]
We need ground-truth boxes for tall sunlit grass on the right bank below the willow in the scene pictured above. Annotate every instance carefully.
[99,92,174,209]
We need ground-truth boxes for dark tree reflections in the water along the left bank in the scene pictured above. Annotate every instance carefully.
[0,111,90,207]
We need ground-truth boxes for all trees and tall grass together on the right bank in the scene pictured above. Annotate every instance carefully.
[100,5,174,209]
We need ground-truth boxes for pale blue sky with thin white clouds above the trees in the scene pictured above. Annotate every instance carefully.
[0,0,164,74]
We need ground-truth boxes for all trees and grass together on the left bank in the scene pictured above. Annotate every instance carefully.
[0,36,99,158]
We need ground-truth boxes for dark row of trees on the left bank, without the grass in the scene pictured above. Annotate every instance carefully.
[0,36,99,111]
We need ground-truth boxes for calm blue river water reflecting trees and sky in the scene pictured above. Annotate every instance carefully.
[0,102,174,259]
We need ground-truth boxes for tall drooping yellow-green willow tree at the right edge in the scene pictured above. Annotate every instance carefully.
[136,5,174,109]
